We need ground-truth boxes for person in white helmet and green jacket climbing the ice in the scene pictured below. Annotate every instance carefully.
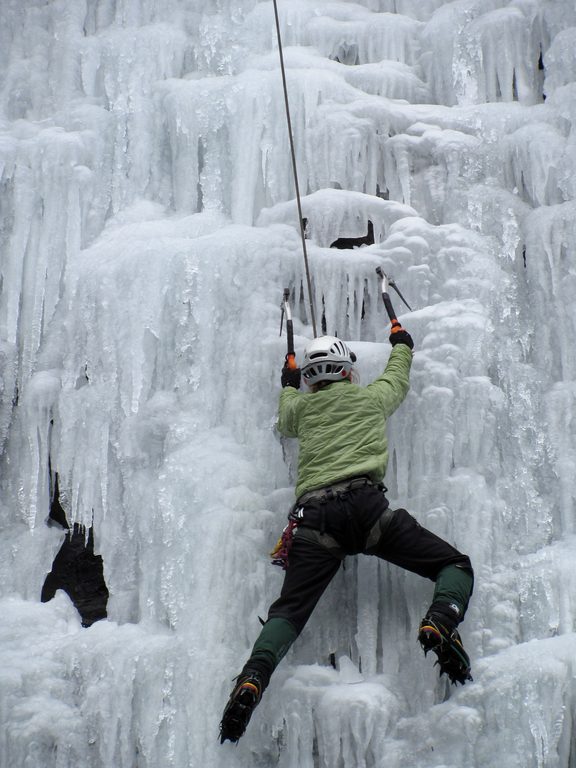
[220,321,474,742]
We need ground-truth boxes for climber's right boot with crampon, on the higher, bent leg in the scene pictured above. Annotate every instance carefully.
[418,612,472,685]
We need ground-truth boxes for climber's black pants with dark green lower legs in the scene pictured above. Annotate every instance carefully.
[245,484,474,678]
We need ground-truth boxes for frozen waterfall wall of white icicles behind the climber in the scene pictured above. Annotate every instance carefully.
[0,0,576,768]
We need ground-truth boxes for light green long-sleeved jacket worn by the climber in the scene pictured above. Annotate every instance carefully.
[277,344,412,498]
